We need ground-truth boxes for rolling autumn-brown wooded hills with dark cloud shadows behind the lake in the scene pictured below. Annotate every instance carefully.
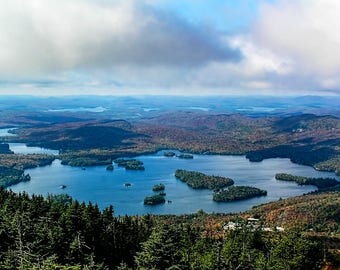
[0,112,340,175]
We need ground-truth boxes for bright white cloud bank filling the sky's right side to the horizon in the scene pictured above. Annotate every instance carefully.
[200,0,340,95]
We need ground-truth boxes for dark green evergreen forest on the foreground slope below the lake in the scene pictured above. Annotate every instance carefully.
[0,190,340,270]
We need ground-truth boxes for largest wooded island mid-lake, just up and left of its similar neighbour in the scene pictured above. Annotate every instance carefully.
[175,170,234,190]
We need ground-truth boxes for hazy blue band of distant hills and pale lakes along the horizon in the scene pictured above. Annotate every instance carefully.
[0,95,340,119]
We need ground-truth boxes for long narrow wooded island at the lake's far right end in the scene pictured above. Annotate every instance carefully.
[275,173,340,189]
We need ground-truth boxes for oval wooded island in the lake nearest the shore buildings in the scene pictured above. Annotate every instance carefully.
[213,186,267,202]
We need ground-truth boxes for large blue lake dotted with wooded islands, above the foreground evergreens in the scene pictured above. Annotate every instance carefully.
[11,151,339,215]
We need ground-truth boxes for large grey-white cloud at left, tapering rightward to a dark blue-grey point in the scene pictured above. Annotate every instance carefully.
[0,0,241,76]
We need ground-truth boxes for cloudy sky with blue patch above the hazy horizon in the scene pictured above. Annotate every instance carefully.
[0,0,340,96]
